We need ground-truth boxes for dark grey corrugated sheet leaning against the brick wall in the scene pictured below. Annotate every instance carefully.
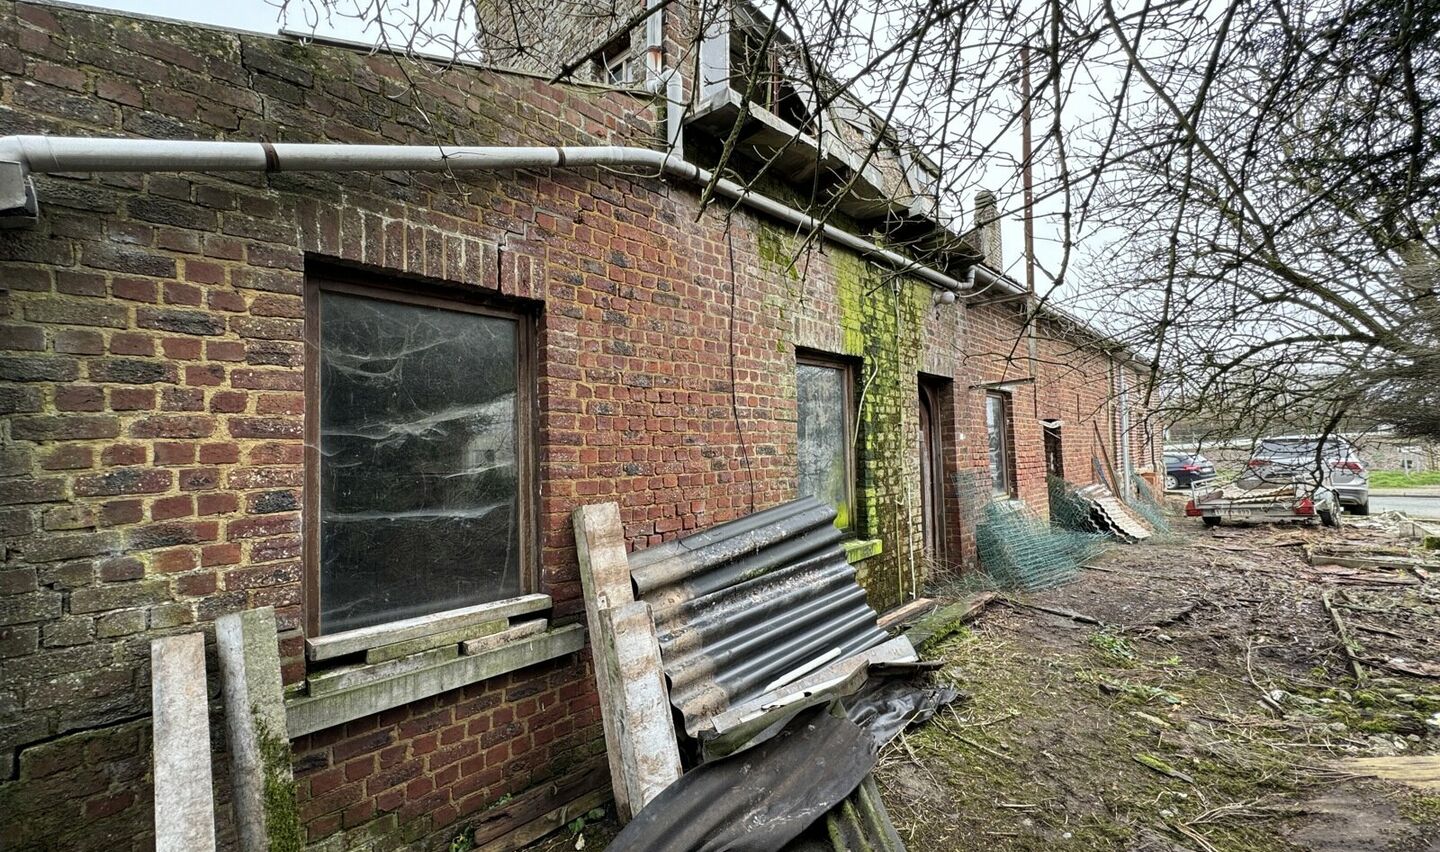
[629,498,886,735]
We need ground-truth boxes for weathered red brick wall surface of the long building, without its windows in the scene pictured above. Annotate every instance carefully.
[0,0,1149,849]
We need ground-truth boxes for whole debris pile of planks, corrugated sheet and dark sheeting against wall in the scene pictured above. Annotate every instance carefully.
[575,498,956,851]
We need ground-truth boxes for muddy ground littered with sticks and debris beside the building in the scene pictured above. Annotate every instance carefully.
[878,520,1440,852]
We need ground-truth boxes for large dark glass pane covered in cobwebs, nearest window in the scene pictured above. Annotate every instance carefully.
[320,291,521,633]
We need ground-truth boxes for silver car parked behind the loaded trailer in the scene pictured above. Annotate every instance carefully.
[1238,435,1369,515]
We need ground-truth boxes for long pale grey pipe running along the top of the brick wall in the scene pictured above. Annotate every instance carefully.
[0,135,973,294]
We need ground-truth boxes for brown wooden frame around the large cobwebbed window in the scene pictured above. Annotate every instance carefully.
[301,268,540,638]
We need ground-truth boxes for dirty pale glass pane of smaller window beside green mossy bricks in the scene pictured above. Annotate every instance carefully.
[795,364,850,530]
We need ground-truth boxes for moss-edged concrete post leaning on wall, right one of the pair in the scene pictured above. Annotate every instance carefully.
[215,606,304,852]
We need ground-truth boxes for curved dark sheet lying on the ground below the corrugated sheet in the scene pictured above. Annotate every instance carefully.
[609,707,876,852]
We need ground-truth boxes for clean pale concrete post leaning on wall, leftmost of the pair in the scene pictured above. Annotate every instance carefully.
[150,633,215,852]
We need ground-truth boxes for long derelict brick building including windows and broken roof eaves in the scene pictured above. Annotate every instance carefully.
[0,0,1155,849]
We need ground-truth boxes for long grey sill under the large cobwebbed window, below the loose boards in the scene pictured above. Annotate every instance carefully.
[285,625,585,738]
